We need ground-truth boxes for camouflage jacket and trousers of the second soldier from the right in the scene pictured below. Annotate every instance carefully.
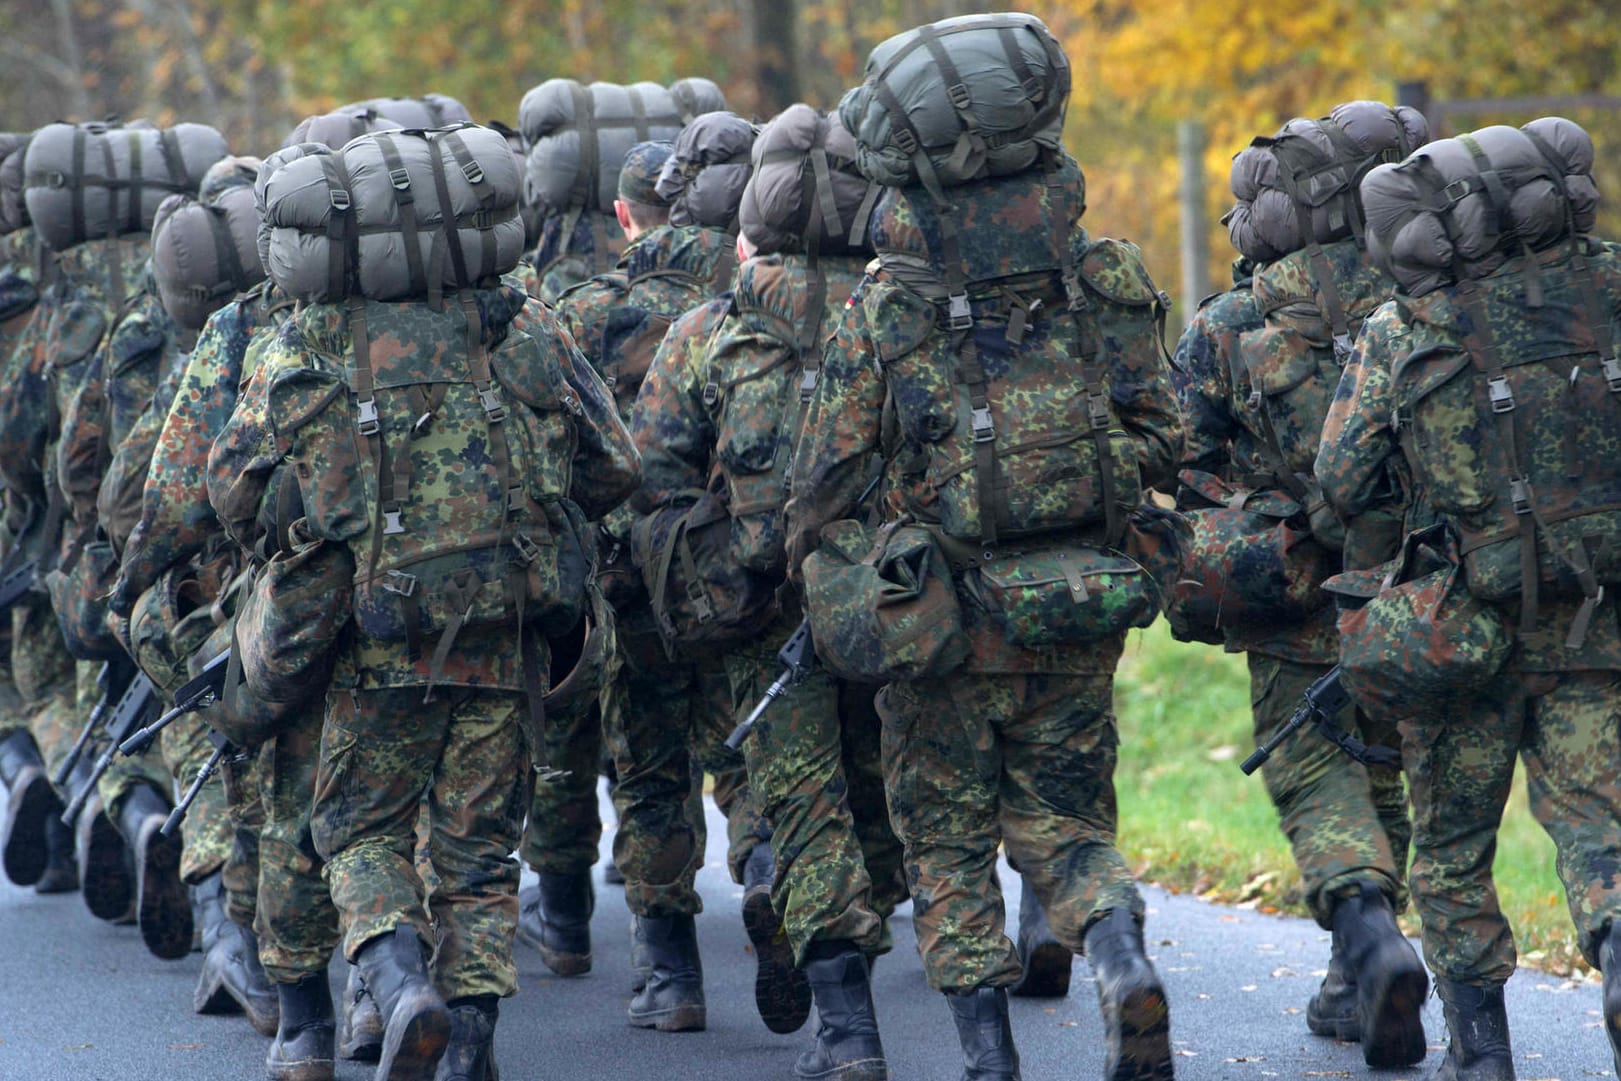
[1170,257,1412,929]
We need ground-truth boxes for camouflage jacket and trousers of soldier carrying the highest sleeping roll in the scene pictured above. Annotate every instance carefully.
[788,173,1182,992]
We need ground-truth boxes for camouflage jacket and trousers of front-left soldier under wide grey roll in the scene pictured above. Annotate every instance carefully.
[209,285,635,1005]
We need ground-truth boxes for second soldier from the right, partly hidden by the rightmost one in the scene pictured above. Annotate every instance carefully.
[1172,102,1425,1066]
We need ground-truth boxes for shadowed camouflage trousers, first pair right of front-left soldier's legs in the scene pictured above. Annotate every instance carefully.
[603,616,770,916]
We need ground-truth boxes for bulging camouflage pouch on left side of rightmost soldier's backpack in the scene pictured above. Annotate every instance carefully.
[1324,527,1514,718]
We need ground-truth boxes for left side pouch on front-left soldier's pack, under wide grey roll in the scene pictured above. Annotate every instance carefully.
[237,540,355,703]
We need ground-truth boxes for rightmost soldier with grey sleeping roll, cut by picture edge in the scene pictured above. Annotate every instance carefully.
[1316,118,1621,1081]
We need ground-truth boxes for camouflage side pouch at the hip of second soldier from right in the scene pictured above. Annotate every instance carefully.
[1170,470,1337,642]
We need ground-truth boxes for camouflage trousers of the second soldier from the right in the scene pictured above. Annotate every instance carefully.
[1248,653,1412,930]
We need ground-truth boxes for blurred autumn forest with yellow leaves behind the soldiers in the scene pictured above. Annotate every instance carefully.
[0,0,1621,314]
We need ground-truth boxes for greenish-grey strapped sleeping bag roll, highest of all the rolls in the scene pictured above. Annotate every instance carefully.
[838,13,1070,188]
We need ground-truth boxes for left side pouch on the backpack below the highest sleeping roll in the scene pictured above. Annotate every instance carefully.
[802,519,969,682]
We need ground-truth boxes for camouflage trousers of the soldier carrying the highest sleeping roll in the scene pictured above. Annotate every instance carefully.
[879,673,1143,992]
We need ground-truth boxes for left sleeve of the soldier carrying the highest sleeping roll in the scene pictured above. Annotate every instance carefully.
[786,279,885,574]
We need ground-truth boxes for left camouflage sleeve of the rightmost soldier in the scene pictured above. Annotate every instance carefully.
[1316,301,1409,520]
